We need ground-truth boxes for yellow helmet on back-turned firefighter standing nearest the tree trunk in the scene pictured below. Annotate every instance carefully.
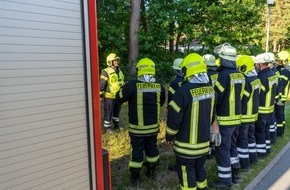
[136,58,155,76]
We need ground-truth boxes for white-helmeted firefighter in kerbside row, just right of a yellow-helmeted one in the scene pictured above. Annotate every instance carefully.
[255,53,278,158]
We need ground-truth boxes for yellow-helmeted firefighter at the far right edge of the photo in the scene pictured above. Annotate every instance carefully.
[275,51,290,136]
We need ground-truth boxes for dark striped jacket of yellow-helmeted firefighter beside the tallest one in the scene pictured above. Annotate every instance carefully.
[241,76,261,124]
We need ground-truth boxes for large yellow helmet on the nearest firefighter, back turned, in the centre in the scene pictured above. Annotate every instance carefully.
[180,53,207,78]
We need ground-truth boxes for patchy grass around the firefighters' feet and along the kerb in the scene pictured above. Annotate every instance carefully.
[102,103,290,190]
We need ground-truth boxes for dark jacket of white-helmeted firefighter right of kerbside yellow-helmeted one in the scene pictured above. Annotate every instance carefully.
[258,68,278,117]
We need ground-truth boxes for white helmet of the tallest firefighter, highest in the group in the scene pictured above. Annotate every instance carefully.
[214,43,237,61]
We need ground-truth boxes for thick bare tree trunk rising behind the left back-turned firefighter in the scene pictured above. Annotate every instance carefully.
[128,0,141,74]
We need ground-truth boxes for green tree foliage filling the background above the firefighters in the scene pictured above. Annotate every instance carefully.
[97,0,290,82]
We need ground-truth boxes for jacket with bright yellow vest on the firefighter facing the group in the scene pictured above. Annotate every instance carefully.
[100,67,124,99]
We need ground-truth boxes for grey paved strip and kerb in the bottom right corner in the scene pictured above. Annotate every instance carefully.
[245,142,290,190]
